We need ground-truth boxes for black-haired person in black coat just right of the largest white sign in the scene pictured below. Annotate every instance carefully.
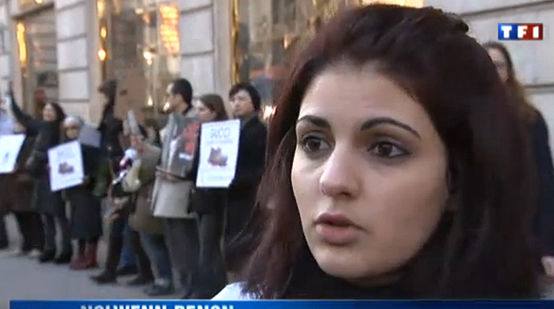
[225,83,267,271]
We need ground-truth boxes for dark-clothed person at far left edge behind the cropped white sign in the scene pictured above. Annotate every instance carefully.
[0,123,44,256]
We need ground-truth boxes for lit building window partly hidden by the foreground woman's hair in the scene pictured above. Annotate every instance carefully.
[232,0,423,118]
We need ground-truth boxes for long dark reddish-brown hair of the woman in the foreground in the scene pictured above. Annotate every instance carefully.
[243,5,538,298]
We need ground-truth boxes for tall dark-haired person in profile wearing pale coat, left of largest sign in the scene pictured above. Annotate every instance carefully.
[152,79,200,298]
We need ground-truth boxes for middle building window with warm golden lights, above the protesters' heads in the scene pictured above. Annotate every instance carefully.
[100,0,180,111]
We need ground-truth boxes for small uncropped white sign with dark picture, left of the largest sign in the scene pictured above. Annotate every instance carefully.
[48,141,85,192]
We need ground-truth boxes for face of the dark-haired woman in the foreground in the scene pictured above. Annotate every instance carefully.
[291,65,448,285]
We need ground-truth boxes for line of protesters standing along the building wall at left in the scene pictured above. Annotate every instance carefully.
[0,73,267,298]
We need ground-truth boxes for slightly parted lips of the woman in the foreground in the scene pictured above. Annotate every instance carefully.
[315,213,361,246]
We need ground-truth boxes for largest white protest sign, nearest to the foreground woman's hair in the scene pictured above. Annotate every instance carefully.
[196,120,240,188]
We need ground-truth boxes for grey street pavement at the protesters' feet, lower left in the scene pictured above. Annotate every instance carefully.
[0,216,177,309]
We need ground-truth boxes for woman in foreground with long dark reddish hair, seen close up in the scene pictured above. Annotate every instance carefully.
[216,5,538,299]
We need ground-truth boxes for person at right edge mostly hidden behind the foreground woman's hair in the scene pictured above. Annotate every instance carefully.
[484,42,554,277]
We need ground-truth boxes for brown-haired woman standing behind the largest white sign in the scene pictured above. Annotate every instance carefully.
[190,94,228,299]
